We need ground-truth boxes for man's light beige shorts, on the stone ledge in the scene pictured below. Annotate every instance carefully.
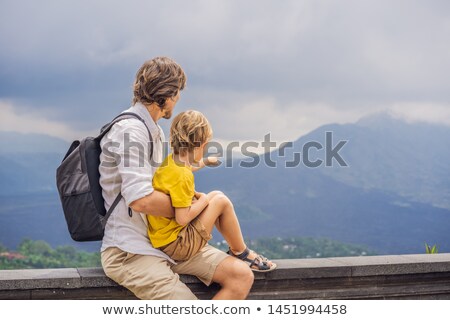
[101,244,229,300]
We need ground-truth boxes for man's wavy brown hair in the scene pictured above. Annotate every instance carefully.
[133,57,186,108]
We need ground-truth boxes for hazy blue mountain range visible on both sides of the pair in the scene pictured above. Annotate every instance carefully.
[0,114,450,253]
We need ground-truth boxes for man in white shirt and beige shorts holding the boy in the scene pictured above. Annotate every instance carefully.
[99,57,253,299]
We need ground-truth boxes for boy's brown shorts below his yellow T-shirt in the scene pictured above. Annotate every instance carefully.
[159,218,212,262]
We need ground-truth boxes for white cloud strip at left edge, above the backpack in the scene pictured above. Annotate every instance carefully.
[0,100,94,141]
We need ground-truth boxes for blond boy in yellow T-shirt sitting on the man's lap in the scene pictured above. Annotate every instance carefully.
[147,110,276,272]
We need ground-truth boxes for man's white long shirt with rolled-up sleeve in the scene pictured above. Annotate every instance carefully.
[99,104,166,257]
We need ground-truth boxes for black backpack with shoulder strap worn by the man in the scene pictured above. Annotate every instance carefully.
[56,112,153,241]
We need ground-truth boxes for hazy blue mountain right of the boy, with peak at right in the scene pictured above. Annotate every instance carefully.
[196,115,450,253]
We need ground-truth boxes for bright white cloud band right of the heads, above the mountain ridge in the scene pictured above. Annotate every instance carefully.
[186,88,450,144]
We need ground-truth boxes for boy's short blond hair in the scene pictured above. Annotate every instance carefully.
[170,110,213,154]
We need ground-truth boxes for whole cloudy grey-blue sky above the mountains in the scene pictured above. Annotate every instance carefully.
[0,0,450,146]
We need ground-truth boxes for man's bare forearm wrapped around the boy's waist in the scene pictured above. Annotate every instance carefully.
[130,190,175,218]
